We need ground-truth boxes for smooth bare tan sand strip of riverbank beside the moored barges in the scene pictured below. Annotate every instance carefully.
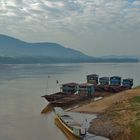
[72,88,140,113]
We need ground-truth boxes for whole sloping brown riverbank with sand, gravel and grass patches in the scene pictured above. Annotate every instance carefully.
[72,87,140,140]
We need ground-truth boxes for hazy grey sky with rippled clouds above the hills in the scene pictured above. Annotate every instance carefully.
[0,0,140,56]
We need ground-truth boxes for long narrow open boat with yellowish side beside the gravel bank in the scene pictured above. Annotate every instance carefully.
[54,107,86,140]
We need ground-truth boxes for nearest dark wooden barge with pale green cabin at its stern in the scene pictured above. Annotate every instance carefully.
[43,83,95,107]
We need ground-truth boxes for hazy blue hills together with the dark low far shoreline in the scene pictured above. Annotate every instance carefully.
[0,34,138,64]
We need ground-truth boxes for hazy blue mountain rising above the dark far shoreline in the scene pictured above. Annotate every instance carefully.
[0,35,89,59]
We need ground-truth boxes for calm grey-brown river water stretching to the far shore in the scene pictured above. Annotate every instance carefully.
[0,63,140,140]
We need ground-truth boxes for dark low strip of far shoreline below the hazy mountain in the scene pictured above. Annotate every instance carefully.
[0,56,140,64]
